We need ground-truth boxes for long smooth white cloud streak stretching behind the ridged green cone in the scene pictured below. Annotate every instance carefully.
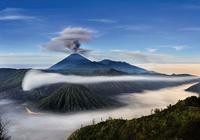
[22,70,198,91]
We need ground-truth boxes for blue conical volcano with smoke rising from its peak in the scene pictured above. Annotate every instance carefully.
[49,53,116,75]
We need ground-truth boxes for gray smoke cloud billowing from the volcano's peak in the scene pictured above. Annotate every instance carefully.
[42,27,95,54]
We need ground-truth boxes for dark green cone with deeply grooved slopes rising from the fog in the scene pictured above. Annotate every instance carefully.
[39,84,119,112]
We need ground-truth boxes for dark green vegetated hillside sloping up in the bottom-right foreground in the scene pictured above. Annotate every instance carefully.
[68,96,200,140]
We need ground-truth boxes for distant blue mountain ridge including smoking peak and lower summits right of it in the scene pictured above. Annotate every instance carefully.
[48,53,154,74]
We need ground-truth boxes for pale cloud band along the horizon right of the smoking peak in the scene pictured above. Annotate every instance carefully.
[90,50,200,64]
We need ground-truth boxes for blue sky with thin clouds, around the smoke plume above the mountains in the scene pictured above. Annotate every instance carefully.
[0,0,200,66]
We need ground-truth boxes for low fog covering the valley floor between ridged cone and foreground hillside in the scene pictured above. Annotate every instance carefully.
[0,84,197,140]
